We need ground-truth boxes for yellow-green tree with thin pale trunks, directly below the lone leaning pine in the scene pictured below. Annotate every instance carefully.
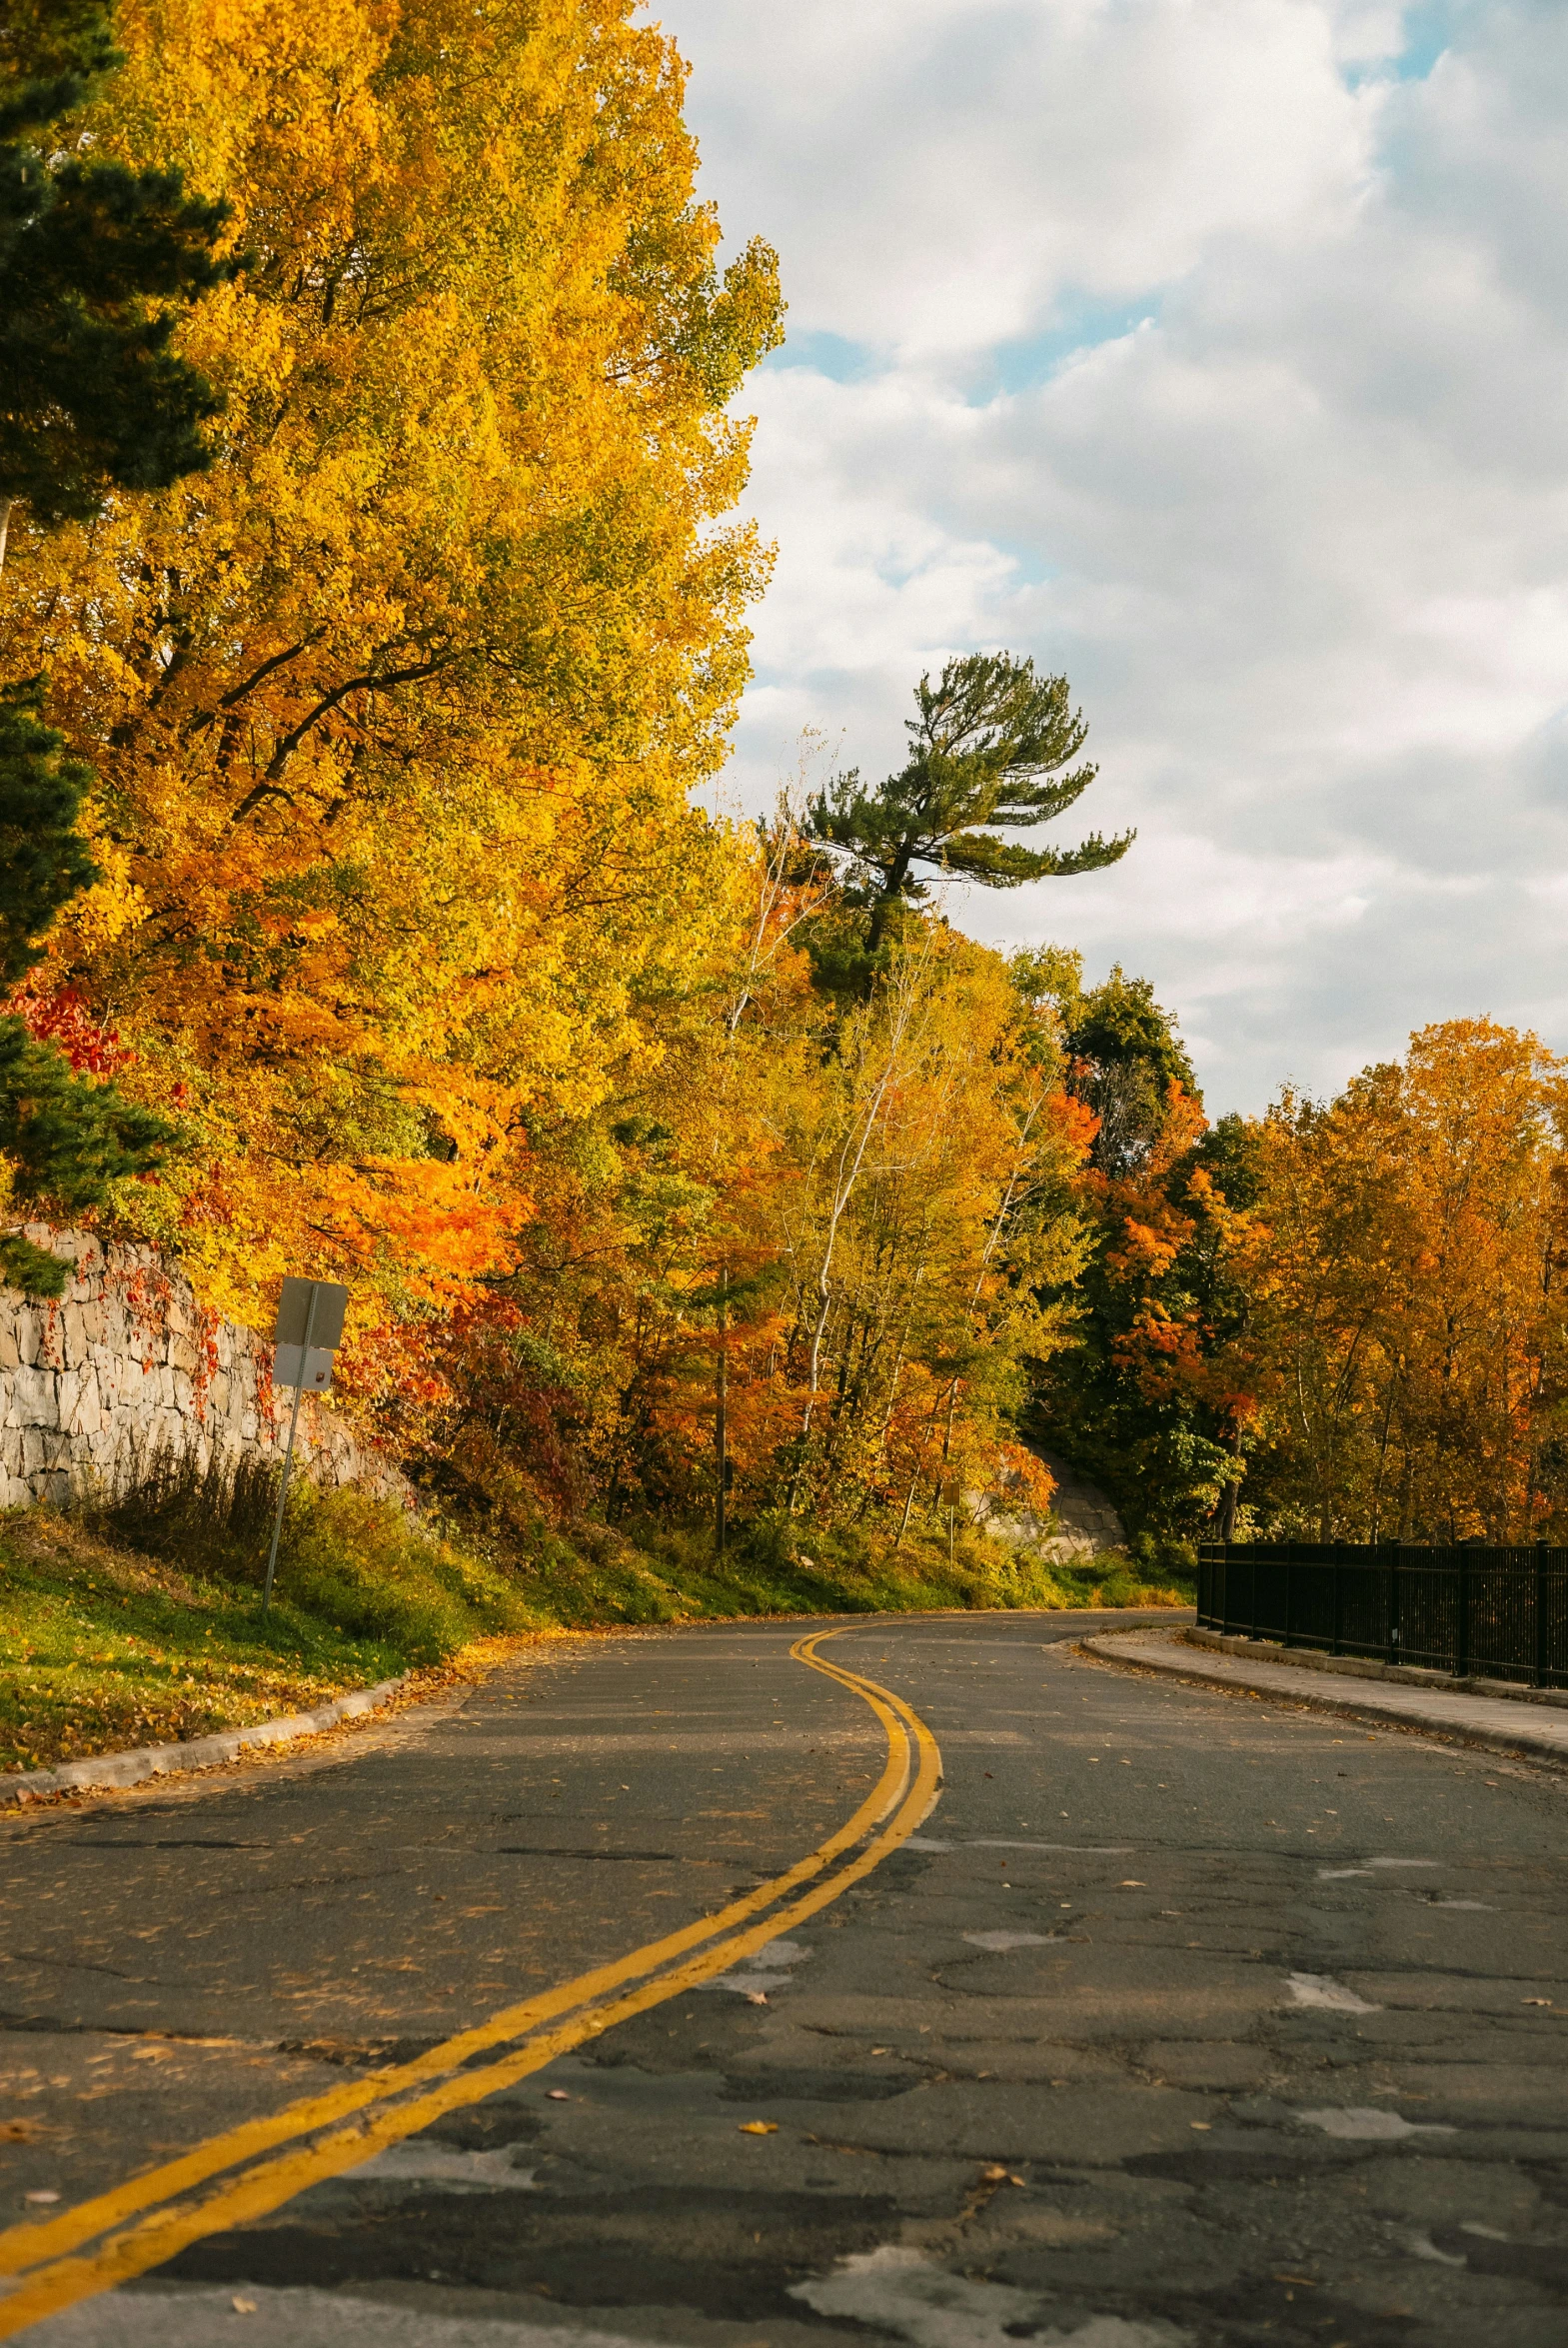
[761,923,1082,1524]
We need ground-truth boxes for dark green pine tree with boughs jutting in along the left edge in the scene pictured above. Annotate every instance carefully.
[0,0,223,1296]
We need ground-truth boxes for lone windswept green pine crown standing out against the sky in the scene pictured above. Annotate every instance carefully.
[800,653,1133,954]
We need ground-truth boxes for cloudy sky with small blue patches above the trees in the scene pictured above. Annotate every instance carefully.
[658,0,1568,1116]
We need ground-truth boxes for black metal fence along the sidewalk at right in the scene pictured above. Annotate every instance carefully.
[1197,1540,1568,1688]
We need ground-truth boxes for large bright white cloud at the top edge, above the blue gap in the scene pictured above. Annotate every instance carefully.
[667,0,1389,357]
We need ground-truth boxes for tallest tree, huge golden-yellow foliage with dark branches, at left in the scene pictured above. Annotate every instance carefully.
[0,0,780,1352]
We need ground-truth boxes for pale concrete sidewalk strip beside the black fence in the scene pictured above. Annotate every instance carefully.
[1082,1629,1568,1761]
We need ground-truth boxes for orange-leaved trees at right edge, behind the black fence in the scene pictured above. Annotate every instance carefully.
[1253,1019,1568,1540]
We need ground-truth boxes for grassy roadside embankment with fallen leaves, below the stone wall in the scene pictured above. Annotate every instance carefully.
[0,1474,1190,1772]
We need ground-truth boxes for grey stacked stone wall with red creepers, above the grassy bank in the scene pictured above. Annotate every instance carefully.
[0,1223,413,1507]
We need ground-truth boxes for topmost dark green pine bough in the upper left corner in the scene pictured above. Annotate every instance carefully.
[0,0,237,559]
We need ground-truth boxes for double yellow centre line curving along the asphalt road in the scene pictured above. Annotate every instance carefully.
[0,1632,941,2339]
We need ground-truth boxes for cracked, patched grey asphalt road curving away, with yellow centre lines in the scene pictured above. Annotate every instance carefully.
[0,1615,1568,2348]
